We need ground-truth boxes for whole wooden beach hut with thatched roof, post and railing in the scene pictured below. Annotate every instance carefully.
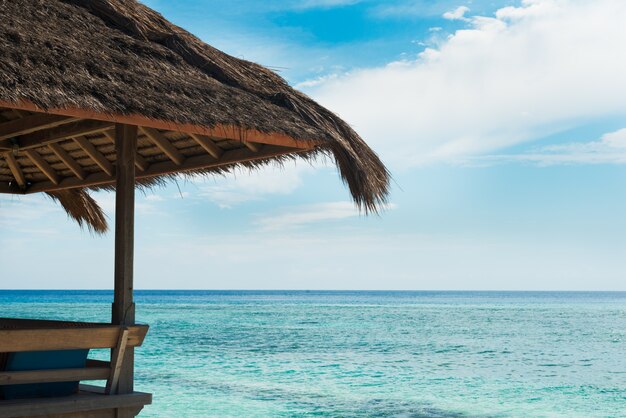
[0,0,389,417]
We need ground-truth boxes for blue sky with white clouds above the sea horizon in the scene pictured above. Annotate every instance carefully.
[0,0,626,290]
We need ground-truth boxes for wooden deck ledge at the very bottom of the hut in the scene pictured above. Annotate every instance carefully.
[0,385,152,418]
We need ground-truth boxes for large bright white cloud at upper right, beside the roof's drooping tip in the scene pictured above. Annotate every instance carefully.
[308,0,626,167]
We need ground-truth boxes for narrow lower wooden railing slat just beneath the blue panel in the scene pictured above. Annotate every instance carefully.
[0,367,111,386]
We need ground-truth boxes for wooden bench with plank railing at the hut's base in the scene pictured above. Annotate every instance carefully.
[0,318,151,417]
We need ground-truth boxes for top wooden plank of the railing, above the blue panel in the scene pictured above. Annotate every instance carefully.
[0,325,148,353]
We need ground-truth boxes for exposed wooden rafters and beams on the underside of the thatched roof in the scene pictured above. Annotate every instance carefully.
[0,111,313,194]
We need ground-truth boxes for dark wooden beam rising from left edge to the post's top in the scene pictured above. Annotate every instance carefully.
[0,120,113,150]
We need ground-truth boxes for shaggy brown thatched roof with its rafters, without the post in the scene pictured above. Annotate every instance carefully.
[0,0,389,230]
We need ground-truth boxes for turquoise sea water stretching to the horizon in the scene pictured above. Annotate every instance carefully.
[0,291,626,417]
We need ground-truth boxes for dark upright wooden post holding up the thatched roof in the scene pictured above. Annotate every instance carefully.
[112,124,137,400]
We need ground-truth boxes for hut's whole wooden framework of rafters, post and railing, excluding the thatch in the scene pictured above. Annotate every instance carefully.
[0,101,319,418]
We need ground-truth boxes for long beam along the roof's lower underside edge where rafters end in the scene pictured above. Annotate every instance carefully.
[26,145,306,194]
